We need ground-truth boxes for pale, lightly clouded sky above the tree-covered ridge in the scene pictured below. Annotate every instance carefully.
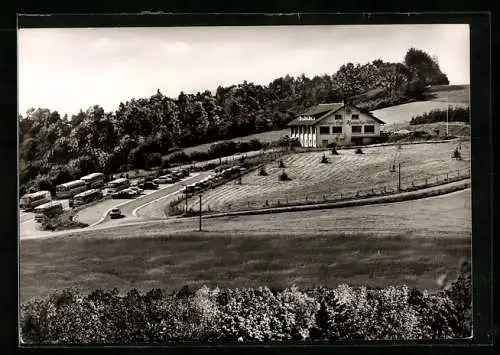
[18,25,469,116]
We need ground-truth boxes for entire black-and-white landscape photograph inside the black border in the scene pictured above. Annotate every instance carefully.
[17,23,475,346]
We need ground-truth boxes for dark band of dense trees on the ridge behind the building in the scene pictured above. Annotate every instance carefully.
[19,48,449,194]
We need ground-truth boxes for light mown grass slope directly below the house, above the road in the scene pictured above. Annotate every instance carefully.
[189,141,470,211]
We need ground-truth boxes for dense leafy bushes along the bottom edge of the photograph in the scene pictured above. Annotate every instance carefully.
[21,266,471,344]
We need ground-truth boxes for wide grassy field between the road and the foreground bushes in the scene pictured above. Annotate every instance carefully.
[20,190,471,302]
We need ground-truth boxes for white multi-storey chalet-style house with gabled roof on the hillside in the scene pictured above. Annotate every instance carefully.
[288,103,385,148]
